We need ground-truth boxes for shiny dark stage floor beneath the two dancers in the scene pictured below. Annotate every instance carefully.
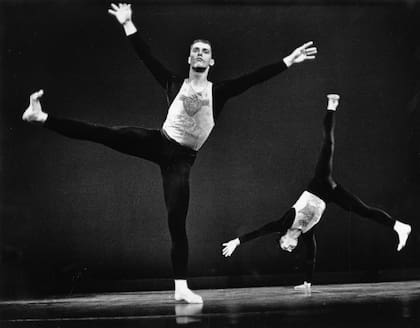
[0,281,420,328]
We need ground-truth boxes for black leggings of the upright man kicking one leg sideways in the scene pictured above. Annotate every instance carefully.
[44,116,197,279]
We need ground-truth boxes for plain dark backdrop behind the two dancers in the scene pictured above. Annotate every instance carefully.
[0,0,420,296]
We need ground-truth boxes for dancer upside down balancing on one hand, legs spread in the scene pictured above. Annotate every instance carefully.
[222,95,411,291]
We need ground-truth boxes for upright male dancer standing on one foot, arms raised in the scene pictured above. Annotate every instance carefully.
[22,4,317,303]
